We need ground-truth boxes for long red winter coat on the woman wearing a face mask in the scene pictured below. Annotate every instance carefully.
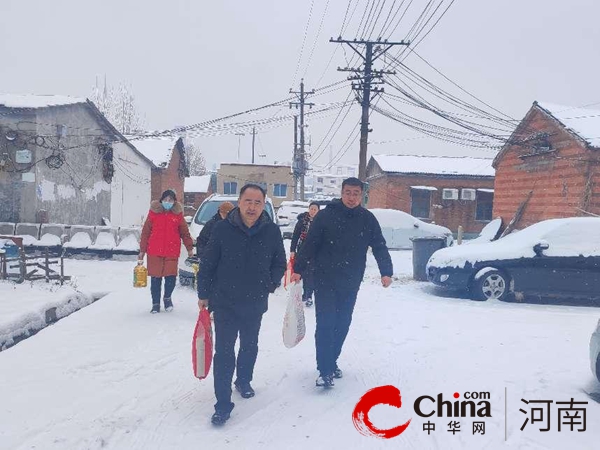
[140,200,194,277]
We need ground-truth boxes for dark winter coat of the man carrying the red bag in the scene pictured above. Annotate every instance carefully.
[197,208,286,314]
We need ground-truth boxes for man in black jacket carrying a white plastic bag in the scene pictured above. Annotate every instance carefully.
[292,178,393,387]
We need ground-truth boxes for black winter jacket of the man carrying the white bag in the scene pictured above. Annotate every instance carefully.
[294,199,393,290]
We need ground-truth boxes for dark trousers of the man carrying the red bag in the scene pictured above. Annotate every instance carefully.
[213,308,262,412]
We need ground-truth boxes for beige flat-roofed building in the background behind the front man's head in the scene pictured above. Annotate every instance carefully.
[217,163,294,208]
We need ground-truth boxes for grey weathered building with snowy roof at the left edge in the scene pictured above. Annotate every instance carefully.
[0,94,154,226]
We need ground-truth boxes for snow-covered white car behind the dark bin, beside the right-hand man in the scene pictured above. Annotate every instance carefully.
[369,208,453,250]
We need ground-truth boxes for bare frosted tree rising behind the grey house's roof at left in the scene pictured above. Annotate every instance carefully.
[91,78,143,134]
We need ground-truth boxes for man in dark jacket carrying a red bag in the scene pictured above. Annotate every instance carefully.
[198,184,286,425]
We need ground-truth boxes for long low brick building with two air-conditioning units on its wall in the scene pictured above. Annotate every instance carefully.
[366,155,494,236]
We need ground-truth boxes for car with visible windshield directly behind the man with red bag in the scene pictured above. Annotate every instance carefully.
[179,194,277,286]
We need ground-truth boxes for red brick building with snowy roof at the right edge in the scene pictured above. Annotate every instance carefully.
[494,102,600,229]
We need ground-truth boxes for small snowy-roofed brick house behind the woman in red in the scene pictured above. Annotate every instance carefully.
[131,138,190,202]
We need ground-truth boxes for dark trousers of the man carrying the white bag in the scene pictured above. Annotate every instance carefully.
[315,286,358,375]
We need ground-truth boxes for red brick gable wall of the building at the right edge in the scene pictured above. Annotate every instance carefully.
[494,107,600,229]
